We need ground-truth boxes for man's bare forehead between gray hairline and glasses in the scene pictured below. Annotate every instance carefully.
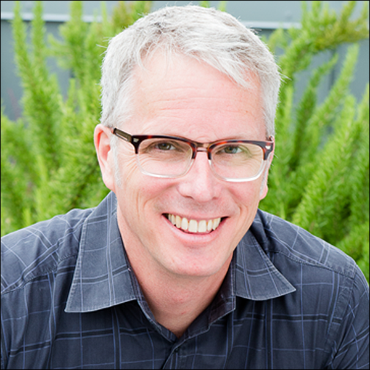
[125,53,265,141]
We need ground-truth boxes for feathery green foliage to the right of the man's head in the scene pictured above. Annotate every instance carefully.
[260,1,369,279]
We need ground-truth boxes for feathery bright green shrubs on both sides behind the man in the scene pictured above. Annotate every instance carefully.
[1,1,369,279]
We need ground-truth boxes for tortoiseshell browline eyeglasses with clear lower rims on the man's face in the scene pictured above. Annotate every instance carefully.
[112,128,274,182]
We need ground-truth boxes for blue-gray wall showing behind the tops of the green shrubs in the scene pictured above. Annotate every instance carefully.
[1,1,369,120]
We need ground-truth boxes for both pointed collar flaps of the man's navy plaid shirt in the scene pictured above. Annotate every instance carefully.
[65,192,295,312]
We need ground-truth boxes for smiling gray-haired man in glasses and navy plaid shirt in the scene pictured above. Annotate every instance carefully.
[2,6,368,368]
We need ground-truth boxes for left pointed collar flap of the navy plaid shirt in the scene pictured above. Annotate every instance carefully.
[65,192,137,312]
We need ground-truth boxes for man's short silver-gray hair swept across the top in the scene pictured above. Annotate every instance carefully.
[101,5,281,137]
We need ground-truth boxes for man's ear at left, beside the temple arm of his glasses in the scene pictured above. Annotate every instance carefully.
[94,124,115,191]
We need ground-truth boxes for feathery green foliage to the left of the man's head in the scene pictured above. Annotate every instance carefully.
[1,1,152,228]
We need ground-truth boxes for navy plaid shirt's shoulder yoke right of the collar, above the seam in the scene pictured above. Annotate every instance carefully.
[251,210,361,279]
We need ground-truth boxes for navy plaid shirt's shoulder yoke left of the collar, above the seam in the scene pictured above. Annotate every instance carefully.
[1,208,93,294]
